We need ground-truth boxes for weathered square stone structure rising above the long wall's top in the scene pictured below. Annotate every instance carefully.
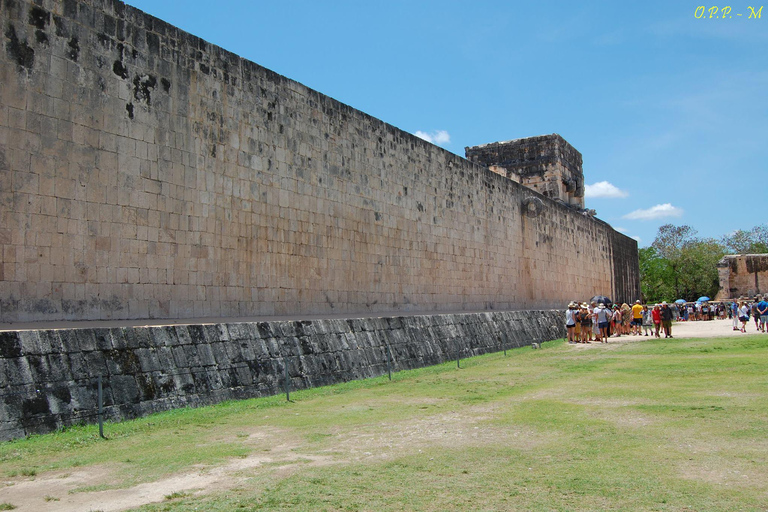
[464,133,584,209]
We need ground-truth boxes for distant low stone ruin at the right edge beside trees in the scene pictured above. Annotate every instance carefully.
[717,254,768,300]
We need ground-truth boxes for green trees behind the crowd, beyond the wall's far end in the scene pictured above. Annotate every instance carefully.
[638,224,768,302]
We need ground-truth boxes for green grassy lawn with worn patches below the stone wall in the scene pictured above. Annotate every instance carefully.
[0,335,768,511]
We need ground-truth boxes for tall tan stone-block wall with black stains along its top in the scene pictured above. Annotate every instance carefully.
[0,0,639,322]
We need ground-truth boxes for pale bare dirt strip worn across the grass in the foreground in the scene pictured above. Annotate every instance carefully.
[0,406,535,512]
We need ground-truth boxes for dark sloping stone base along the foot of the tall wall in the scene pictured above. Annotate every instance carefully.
[0,311,565,440]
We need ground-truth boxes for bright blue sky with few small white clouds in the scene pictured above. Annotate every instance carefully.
[128,0,768,247]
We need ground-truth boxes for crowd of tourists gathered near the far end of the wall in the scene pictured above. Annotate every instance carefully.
[565,295,768,343]
